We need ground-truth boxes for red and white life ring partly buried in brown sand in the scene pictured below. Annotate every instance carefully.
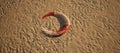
[41,12,70,37]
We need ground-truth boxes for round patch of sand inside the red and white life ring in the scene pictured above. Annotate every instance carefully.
[41,16,60,31]
